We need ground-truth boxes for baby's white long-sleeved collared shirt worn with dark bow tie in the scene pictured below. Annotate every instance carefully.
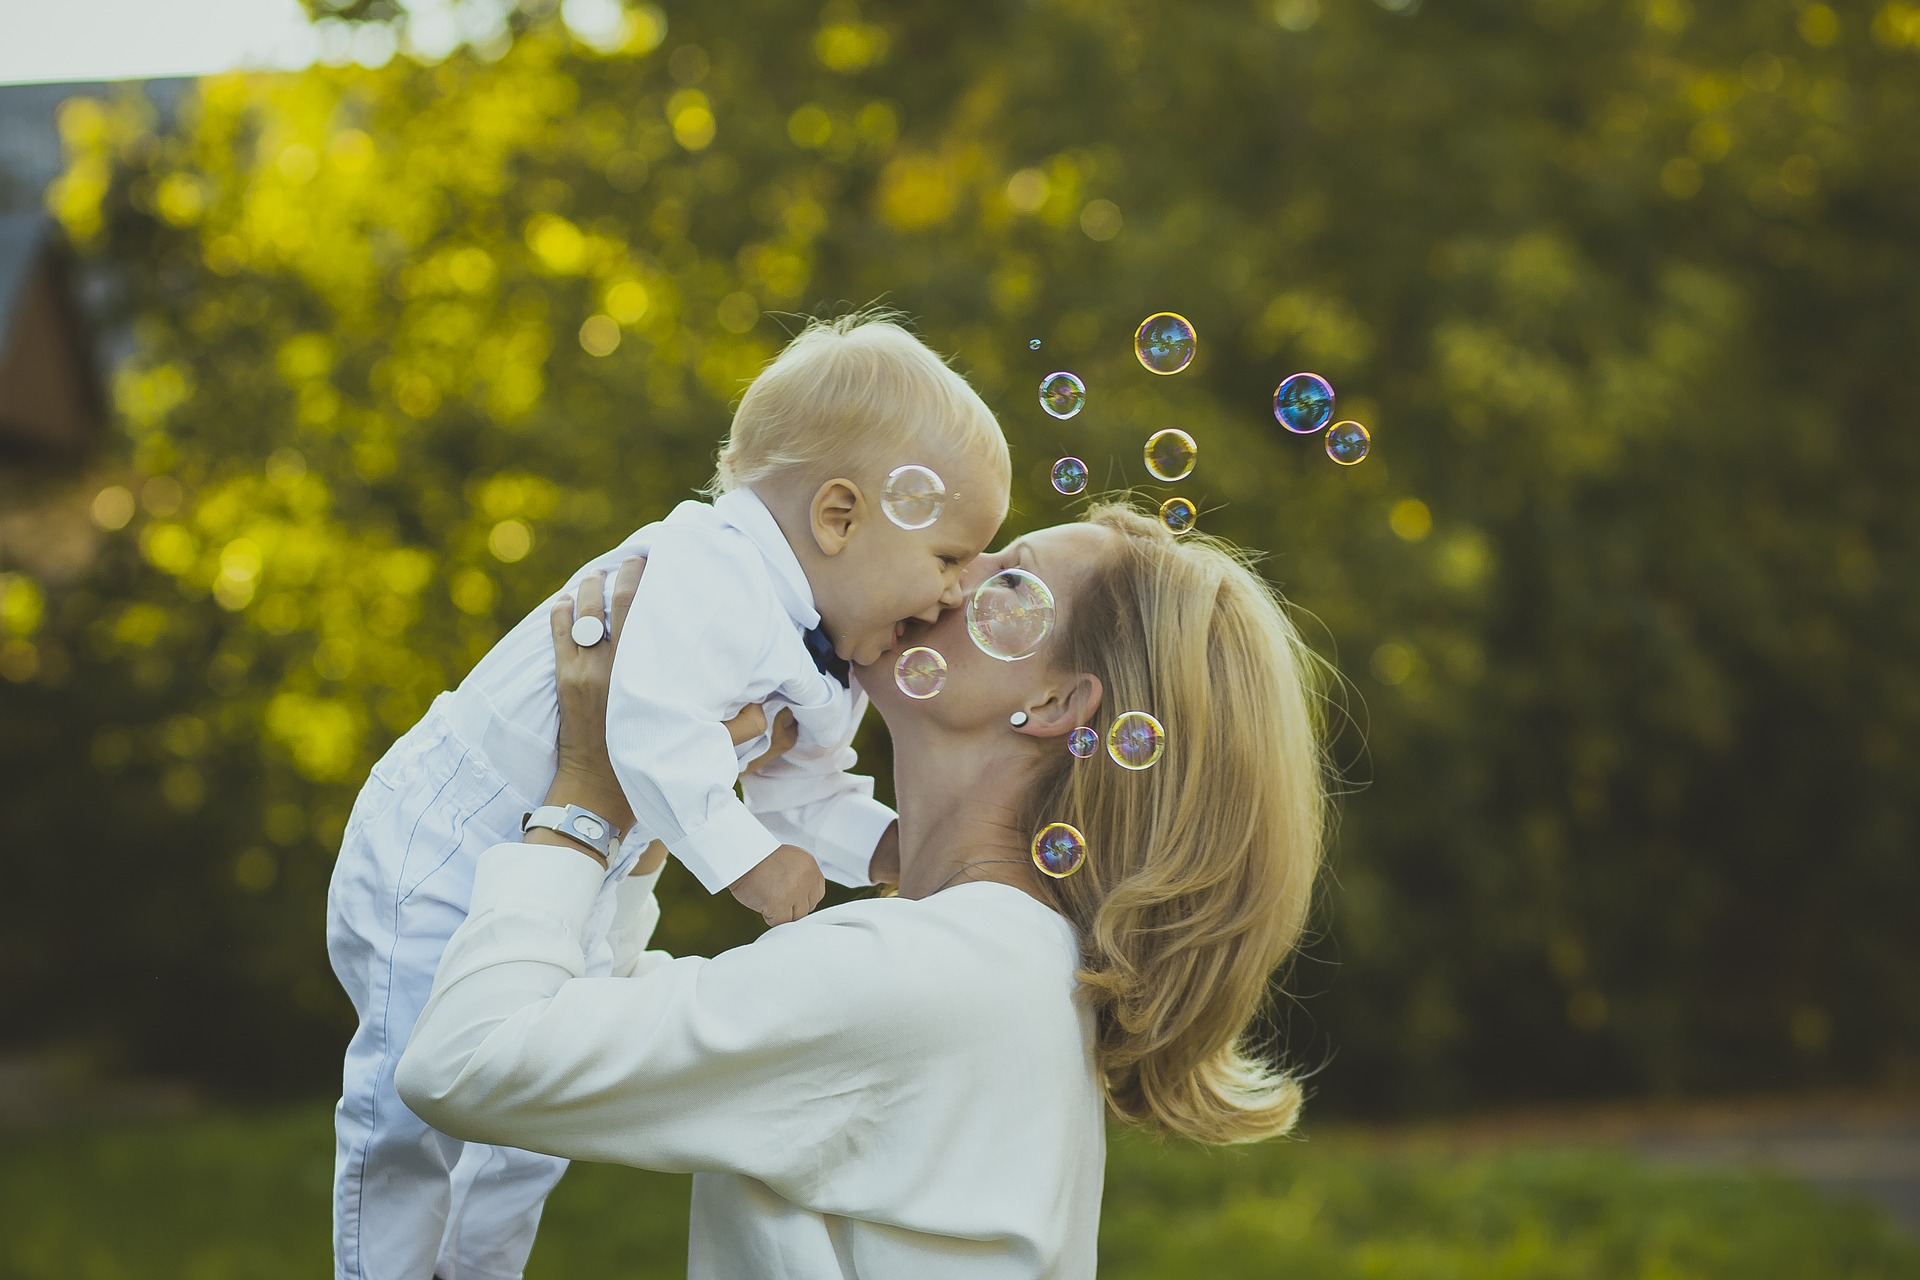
[455,489,895,892]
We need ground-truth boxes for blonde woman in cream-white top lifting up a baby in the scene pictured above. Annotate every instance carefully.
[399,507,1325,1278]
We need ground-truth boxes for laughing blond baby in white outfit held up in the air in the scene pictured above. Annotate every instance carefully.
[326,315,1010,1280]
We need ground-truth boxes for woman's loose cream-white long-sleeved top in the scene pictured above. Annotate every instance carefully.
[397,844,1106,1280]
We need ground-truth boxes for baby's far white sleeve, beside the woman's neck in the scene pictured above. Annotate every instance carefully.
[739,695,895,887]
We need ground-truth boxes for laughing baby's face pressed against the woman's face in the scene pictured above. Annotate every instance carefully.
[814,445,1008,666]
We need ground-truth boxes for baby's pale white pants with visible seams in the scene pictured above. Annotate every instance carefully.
[326,695,628,1280]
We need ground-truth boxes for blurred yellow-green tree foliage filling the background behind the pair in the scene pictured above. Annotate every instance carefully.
[0,0,1920,1109]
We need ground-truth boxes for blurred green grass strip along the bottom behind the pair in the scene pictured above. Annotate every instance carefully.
[0,1105,1920,1280]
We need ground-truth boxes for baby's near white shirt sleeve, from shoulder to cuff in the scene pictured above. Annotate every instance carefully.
[607,533,785,892]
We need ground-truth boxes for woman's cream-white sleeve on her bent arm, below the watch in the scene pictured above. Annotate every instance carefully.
[396,844,929,1203]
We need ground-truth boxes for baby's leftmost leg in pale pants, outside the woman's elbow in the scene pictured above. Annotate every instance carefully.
[326,718,522,1280]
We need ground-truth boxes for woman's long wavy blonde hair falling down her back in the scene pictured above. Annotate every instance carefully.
[1021,503,1329,1142]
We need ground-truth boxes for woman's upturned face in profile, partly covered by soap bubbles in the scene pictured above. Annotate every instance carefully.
[856,524,1119,727]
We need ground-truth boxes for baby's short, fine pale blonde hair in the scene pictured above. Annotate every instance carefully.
[707,309,1012,497]
